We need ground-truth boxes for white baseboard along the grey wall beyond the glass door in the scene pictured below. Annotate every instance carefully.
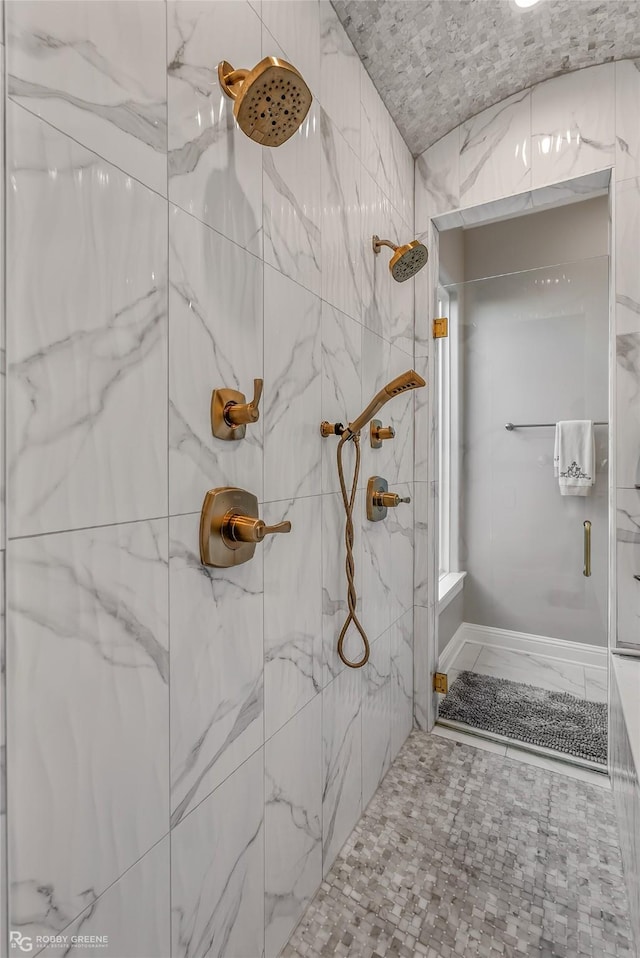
[438,622,607,672]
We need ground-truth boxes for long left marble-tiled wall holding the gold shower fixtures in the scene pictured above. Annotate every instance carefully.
[0,0,414,958]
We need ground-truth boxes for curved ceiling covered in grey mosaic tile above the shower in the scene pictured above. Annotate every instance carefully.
[332,0,640,155]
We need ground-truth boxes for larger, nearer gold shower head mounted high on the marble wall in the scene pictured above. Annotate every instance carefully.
[218,57,313,146]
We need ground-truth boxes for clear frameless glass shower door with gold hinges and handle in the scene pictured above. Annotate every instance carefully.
[440,256,609,748]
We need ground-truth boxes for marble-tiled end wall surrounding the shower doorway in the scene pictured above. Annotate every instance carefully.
[414,60,640,952]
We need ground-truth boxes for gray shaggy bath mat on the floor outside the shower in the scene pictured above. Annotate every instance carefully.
[439,672,607,765]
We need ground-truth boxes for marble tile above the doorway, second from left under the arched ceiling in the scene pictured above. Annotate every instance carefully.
[460,90,531,206]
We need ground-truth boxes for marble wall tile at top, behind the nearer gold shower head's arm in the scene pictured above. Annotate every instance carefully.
[167,0,262,256]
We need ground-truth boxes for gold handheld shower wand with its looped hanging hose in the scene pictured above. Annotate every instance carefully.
[321,369,426,669]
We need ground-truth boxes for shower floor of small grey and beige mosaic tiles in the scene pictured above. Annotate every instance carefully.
[282,732,636,958]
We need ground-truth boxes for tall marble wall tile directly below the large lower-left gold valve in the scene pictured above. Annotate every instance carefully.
[169,514,264,826]
